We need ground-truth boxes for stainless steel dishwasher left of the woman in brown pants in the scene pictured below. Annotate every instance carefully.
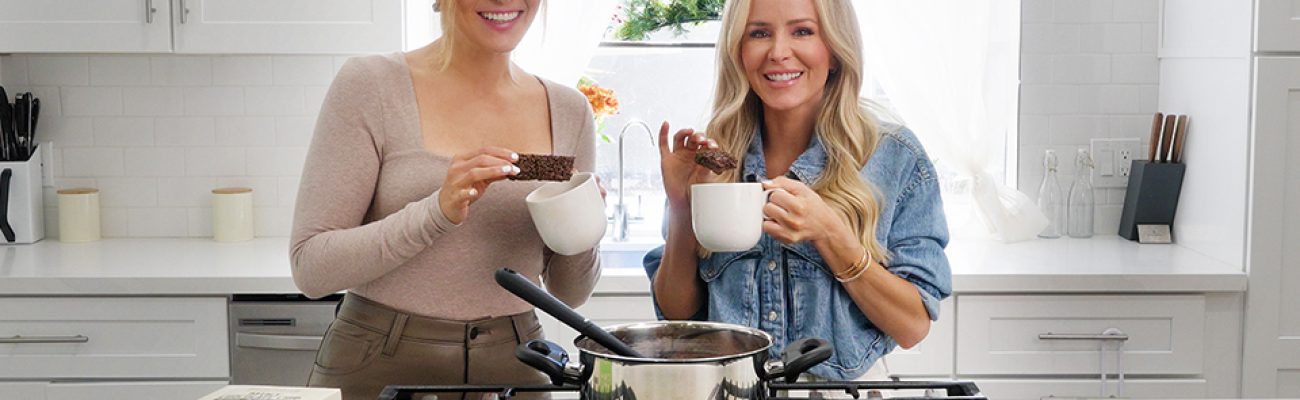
[230,295,343,386]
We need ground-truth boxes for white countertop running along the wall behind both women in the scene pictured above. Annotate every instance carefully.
[0,236,1247,295]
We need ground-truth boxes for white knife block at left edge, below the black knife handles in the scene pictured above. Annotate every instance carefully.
[0,149,46,244]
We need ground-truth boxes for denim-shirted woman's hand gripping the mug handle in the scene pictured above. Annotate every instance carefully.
[763,177,848,244]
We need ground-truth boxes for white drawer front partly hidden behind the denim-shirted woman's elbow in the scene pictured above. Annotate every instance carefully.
[884,299,957,379]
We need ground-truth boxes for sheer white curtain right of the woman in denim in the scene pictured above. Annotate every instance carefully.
[855,0,1048,242]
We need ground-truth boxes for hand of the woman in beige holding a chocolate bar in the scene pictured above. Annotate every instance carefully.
[438,147,519,225]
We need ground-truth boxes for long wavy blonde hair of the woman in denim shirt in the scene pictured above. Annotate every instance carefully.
[702,0,889,264]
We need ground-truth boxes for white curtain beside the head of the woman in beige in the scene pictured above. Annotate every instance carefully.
[514,0,619,86]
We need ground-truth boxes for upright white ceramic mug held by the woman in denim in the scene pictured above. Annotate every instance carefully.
[690,182,775,252]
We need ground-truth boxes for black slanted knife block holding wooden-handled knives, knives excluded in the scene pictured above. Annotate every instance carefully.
[1119,160,1187,240]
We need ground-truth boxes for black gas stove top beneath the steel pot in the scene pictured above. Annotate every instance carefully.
[380,381,988,400]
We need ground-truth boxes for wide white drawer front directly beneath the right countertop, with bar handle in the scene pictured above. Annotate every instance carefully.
[957,295,1205,375]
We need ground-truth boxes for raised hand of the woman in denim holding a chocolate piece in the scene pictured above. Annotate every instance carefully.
[659,121,718,208]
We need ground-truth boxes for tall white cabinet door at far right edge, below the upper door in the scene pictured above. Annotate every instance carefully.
[1242,57,1300,397]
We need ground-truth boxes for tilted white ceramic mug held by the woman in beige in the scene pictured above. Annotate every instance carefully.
[524,173,606,256]
